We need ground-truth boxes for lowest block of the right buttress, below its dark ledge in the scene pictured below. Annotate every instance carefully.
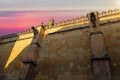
[92,59,111,80]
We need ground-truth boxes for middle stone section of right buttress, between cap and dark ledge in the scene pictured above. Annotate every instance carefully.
[90,33,107,58]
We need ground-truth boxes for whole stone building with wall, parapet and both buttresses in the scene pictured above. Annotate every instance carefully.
[0,9,120,80]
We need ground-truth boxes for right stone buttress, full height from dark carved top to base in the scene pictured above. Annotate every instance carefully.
[88,12,111,80]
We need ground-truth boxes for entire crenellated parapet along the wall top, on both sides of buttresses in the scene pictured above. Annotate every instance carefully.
[1,9,120,39]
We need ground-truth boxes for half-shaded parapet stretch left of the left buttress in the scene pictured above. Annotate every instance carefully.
[0,25,42,44]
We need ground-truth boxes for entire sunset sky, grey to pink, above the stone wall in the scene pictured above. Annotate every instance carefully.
[0,0,120,36]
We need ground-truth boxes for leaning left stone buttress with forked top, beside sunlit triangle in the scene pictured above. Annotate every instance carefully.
[19,26,44,80]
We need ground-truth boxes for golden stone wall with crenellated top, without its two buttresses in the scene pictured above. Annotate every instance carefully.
[0,10,120,80]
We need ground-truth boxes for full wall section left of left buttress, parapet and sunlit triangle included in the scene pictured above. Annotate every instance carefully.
[0,27,40,80]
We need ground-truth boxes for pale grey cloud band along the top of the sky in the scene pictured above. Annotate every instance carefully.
[0,0,120,10]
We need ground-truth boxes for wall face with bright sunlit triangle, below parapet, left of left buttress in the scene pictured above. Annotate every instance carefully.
[0,34,32,80]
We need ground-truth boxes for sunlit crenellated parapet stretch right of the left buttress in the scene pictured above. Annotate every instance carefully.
[46,9,120,29]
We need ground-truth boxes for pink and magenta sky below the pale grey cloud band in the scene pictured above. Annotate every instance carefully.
[0,10,89,36]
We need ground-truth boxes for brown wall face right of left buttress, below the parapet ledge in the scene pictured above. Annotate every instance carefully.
[33,23,120,80]
